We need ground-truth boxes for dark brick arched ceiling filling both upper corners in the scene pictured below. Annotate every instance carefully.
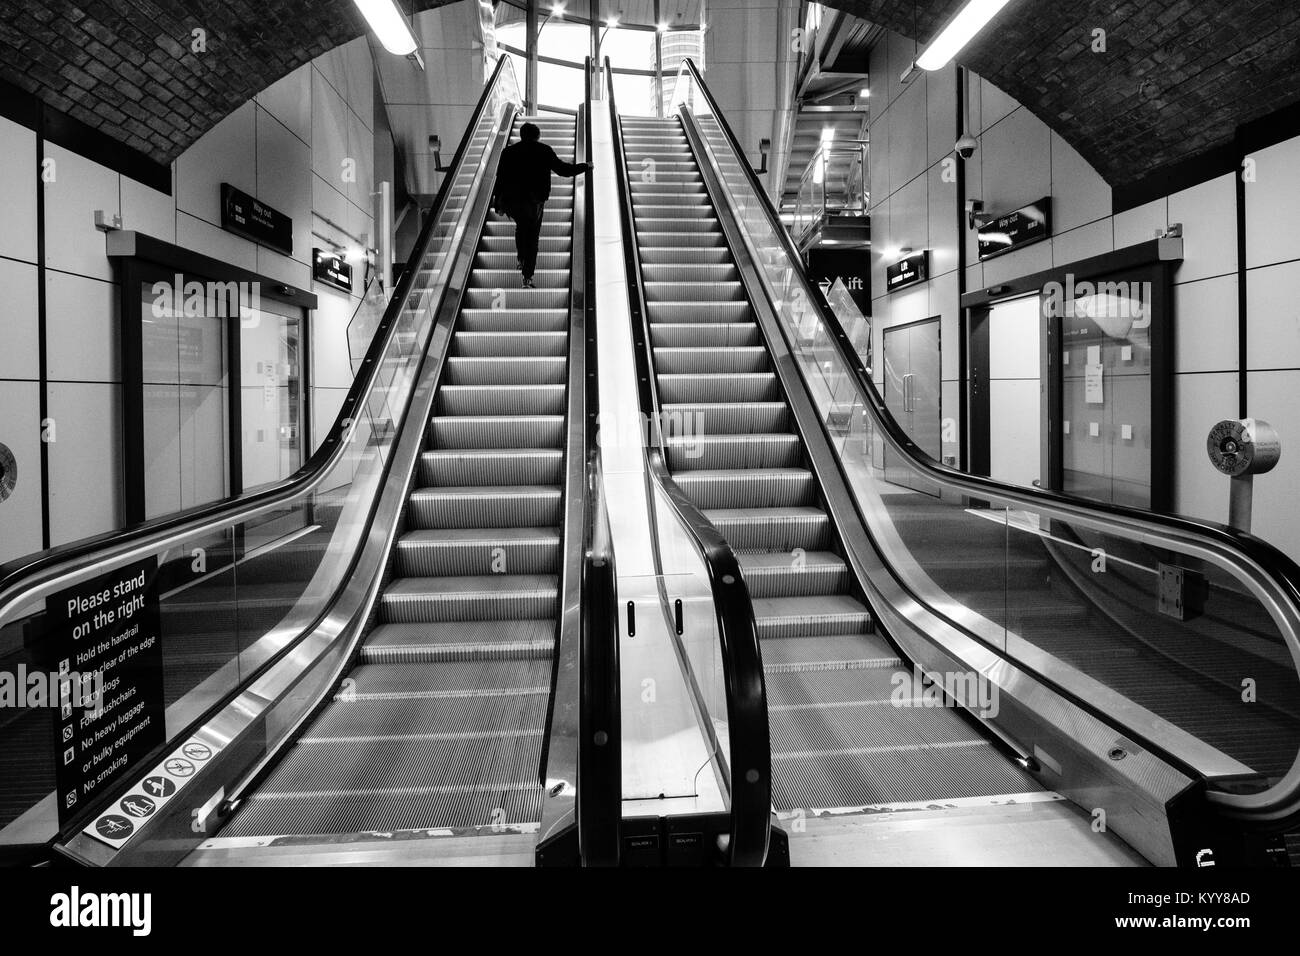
[0,0,1300,185]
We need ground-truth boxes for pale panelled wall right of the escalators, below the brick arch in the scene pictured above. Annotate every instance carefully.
[870,27,1300,555]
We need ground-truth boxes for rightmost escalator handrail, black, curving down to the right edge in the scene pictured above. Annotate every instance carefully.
[679,59,1300,814]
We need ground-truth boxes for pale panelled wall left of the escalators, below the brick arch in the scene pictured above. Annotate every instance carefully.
[0,38,379,561]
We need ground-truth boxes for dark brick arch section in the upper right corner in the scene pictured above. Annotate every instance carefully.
[823,0,1300,186]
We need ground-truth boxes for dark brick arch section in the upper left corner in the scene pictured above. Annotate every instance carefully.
[0,0,451,164]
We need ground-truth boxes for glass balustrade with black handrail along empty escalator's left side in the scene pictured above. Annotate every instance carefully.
[605,60,772,866]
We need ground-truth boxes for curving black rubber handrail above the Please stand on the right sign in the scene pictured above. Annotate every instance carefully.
[0,57,517,613]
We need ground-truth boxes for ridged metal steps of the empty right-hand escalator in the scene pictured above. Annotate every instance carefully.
[621,117,1041,812]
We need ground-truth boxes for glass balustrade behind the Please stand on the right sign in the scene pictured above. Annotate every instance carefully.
[0,60,519,845]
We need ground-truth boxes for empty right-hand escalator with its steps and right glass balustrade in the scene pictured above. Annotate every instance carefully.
[611,61,1300,865]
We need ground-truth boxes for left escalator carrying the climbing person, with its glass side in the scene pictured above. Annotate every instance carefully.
[0,57,621,866]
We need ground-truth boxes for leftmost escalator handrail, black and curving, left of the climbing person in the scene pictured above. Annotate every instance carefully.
[0,57,514,627]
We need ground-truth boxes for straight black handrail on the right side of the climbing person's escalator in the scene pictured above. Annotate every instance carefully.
[575,57,623,866]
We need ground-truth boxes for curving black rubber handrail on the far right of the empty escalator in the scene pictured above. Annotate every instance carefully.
[681,59,1300,816]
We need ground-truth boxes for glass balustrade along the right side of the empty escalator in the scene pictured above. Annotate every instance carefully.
[683,57,1300,819]
